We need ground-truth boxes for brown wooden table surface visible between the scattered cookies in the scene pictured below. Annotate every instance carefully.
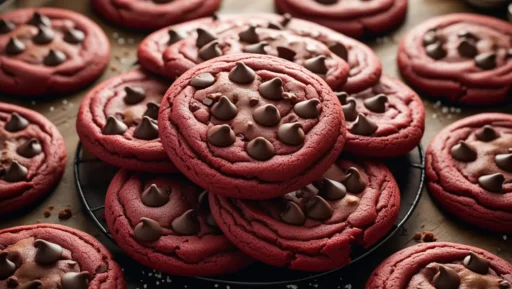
[0,0,512,288]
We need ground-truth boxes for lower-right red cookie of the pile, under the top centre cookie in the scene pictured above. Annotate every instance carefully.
[210,157,400,271]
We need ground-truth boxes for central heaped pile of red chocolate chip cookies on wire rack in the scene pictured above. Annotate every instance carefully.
[77,14,424,275]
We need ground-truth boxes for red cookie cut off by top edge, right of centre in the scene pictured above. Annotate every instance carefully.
[275,0,407,38]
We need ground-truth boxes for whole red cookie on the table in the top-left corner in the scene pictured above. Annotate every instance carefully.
[0,8,110,97]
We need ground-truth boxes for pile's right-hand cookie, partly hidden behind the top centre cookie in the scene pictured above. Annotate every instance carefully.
[337,76,425,157]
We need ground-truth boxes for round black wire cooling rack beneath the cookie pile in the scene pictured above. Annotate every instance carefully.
[74,143,425,289]
